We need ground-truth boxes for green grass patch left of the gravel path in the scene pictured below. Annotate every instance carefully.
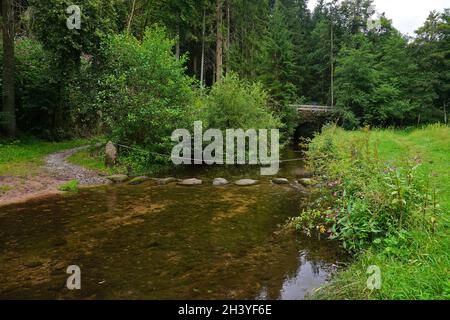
[0,139,96,176]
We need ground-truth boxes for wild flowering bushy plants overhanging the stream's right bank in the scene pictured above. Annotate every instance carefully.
[294,126,439,252]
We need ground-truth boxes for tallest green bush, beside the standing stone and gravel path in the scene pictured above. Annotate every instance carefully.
[98,26,194,171]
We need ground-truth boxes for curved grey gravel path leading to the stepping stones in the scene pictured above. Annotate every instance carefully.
[45,144,109,185]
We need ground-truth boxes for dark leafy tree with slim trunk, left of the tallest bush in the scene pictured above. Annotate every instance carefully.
[30,0,123,131]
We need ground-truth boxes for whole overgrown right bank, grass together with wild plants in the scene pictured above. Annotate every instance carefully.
[313,125,450,300]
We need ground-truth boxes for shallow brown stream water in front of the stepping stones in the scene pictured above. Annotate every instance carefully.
[0,151,339,299]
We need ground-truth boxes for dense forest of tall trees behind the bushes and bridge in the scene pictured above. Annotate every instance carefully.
[0,0,450,139]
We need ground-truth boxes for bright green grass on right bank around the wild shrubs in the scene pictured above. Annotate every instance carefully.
[313,125,450,299]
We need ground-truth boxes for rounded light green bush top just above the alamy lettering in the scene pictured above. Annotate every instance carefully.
[202,73,282,130]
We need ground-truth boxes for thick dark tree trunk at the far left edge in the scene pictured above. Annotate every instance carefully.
[2,0,16,137]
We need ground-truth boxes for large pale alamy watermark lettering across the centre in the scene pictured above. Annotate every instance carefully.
[171,121,280,176]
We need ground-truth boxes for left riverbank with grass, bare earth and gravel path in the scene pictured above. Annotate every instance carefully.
[0,139,106,206]
